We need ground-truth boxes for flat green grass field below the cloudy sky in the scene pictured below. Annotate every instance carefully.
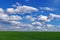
[0,32,60,40]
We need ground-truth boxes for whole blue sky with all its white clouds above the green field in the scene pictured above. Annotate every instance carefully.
[0,0,60,31]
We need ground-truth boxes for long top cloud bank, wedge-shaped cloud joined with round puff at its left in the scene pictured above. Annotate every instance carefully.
[6,5,38,14]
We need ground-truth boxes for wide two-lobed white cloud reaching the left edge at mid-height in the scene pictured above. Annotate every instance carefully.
[0,13,22,22]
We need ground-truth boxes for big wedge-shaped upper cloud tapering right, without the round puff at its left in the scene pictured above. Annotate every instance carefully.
[15,5,38,13]
